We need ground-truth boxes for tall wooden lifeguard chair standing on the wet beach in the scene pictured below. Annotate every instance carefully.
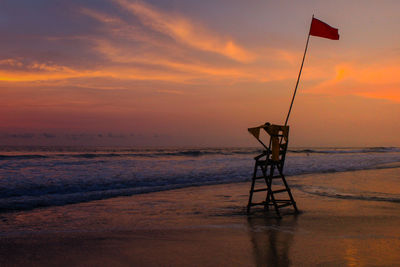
[247,122,298,218]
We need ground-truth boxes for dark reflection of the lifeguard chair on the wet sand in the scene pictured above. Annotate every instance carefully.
[247,215,297,266]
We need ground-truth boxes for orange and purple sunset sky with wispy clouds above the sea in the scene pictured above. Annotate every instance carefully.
[0,0,400,147]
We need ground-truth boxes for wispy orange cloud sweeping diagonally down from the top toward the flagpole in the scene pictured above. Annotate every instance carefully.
[75,4,315,87]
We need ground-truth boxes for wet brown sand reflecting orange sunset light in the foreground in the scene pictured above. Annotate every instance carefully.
[0,168,400,266]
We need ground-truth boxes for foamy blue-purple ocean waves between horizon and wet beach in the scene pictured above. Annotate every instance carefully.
[0,146,400,212]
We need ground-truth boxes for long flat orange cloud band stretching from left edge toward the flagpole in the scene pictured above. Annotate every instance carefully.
[0,52,294,89]
